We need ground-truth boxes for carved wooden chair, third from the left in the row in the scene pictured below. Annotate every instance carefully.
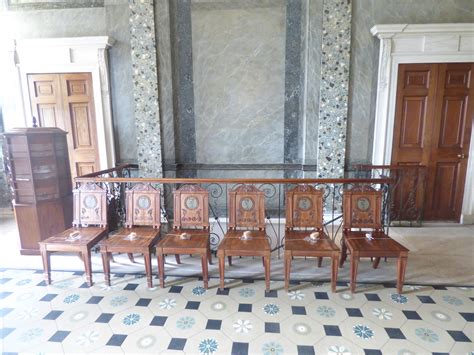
[156,185,212,288]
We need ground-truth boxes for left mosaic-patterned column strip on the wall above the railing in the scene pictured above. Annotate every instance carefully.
[129,0,163,178]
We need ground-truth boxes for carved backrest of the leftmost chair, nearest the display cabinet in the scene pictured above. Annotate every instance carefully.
[72,183,107,228]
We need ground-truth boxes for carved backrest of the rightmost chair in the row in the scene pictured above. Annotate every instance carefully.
[343,185,383,230]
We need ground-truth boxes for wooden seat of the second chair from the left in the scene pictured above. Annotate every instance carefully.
[99,227,160,252]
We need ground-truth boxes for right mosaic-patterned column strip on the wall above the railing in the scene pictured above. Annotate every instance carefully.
[318,0,351,178]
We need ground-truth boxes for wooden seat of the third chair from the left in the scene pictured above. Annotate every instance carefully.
[156,229,209,254]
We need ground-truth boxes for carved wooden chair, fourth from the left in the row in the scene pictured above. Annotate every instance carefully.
[217,185,271,291]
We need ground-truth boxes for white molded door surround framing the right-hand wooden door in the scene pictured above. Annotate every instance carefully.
[370,23,474,221]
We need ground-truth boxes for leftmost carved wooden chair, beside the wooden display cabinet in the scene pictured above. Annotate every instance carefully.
[39,184,108,286]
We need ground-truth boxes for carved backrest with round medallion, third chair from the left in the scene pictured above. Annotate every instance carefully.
[173,185,209,229]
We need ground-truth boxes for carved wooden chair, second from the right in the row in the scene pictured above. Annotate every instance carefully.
[285,185,340,292]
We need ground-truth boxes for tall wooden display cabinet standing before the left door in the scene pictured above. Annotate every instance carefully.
[4,128,72,255]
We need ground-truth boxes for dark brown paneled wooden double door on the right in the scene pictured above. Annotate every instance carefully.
[392,63,474,220]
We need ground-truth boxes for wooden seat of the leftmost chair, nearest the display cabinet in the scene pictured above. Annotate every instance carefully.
[39,227,107,251]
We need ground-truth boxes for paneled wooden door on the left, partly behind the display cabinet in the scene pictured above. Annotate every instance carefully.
[28,73,100,177]
